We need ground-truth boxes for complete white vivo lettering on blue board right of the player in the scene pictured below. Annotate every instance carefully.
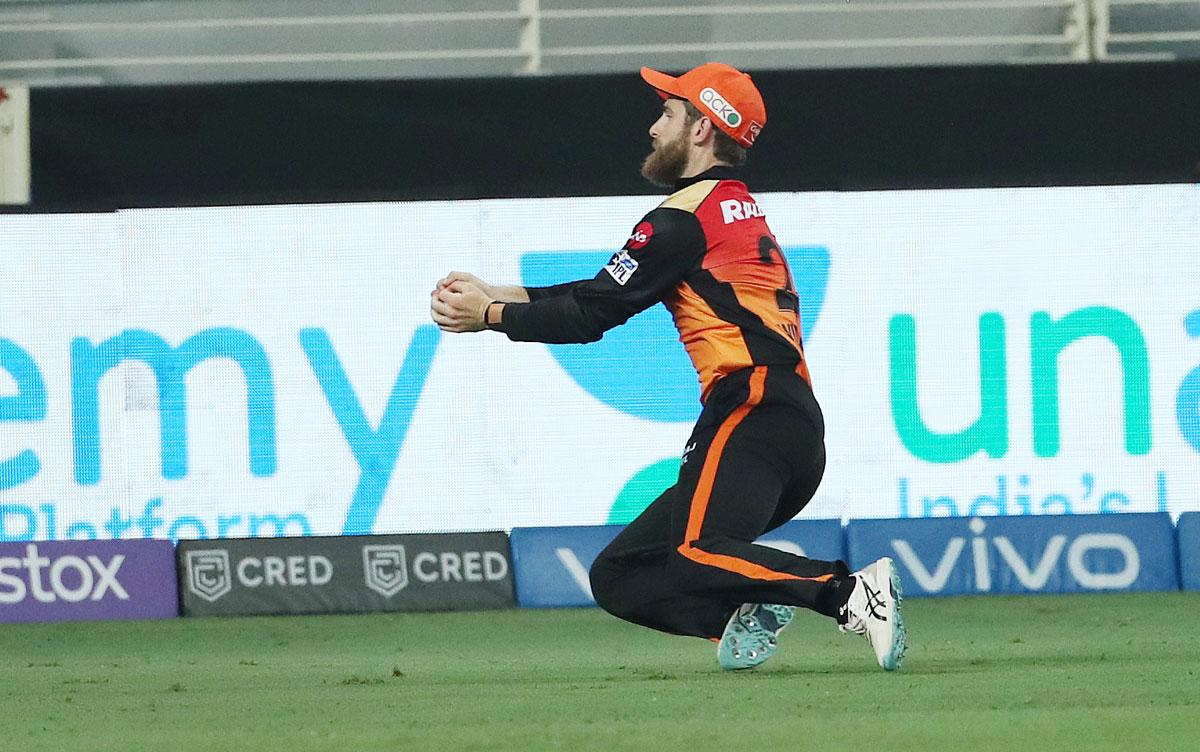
[890,517,1141,592]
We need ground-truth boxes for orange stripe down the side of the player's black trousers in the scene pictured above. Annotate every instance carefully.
[678,366,833,582]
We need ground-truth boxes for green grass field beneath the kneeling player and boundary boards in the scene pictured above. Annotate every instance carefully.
[0,592,1200,752]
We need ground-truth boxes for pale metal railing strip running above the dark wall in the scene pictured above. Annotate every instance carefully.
[0,0,1200,84]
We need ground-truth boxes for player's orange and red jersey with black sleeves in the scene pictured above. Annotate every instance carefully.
[493,167,809,401]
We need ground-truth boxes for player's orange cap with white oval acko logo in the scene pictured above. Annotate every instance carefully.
[642,62,767,146]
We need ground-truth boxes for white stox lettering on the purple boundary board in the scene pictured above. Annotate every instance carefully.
[0,543,130,604]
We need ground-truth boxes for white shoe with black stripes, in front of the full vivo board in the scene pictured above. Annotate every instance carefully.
[838,557,908,672]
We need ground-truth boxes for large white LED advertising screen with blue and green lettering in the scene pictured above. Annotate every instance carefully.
[0,186,1200,540]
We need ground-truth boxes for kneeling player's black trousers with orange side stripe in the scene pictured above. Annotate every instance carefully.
[592,366,851,638]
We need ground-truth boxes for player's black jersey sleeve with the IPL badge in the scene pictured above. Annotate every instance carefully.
[492,209,706,343]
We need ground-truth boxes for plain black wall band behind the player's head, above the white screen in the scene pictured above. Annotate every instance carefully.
[31,62,1200,210]
